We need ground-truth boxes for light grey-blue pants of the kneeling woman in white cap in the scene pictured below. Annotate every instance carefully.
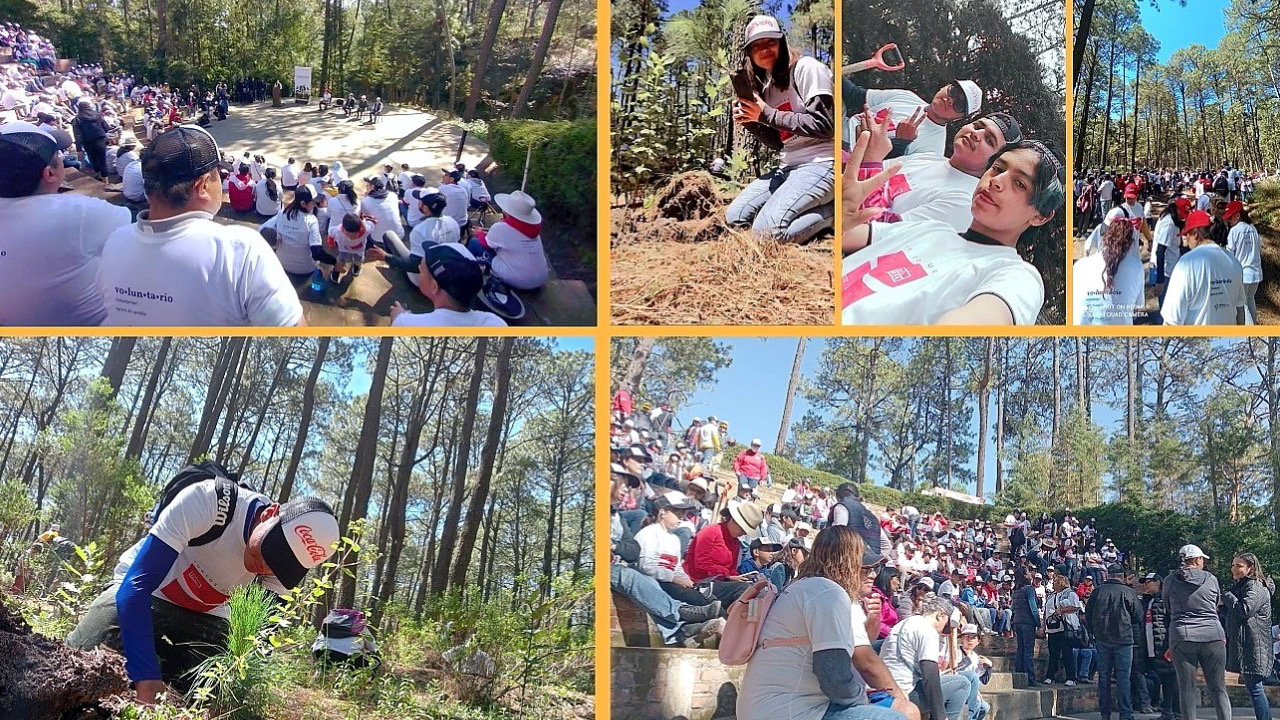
[724,160,836,242]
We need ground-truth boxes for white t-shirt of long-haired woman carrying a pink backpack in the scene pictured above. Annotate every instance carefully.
[737,578,855,720]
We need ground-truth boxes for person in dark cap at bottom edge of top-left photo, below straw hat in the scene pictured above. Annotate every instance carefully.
[392,242,507,328]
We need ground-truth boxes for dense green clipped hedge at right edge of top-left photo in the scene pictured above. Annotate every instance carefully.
[489,119,596,242]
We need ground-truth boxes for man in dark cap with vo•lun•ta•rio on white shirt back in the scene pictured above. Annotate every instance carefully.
[97,126,303,327]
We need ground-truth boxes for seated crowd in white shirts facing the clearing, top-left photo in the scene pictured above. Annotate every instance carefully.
[0,32,550,327]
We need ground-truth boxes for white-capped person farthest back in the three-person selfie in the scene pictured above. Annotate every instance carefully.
[840,63,982,158]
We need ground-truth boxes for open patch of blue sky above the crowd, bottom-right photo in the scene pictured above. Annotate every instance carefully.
[676,337,823,452]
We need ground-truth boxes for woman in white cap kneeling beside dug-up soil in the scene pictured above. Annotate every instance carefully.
[724,15,836,242]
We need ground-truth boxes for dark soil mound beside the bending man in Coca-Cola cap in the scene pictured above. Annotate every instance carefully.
[0,597,129,720]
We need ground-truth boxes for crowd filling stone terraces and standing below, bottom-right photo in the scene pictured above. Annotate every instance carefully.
[609,399,1276,720]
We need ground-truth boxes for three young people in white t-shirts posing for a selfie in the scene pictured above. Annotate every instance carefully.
[841,46,1066,325]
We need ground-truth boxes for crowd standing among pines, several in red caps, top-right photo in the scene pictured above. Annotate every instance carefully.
[1071,165,1280,325]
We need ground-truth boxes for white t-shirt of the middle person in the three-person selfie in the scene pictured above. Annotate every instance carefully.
[877,154,978,232]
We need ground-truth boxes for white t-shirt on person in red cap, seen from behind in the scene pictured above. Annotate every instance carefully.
[1160,242,1244,325]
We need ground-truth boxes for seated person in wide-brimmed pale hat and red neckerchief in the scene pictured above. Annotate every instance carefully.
[467,190,550,290]
